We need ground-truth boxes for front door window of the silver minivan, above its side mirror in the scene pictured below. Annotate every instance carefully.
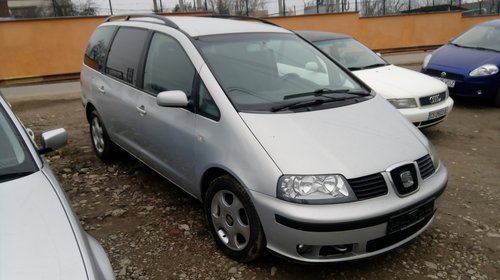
[144,33,195,97]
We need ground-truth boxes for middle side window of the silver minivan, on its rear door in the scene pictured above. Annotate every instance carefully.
[105,27,148,85]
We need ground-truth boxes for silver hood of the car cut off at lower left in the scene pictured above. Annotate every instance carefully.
[0,172,87,280]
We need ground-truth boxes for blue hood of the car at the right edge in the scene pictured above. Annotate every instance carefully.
[427,44,500,75]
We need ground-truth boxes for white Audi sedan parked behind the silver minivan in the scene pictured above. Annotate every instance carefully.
[297,31,453,128]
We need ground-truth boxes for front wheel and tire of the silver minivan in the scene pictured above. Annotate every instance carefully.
[204,175,266,262]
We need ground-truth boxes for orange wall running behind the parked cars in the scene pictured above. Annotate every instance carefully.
[0,12,500,83]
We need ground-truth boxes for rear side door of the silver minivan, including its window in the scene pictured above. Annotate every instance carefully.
[100,27,149,154]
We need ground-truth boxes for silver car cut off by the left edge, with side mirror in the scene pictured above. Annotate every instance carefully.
[0,92,114,280]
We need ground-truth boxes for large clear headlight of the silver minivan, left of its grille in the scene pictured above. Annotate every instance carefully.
[277,175,357,204]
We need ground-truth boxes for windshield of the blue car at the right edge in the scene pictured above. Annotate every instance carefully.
[450,25,500,52]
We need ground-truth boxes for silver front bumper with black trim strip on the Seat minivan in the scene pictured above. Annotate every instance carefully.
[251,165,448,263]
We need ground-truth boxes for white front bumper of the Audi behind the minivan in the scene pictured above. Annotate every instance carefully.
[398,97,454,128]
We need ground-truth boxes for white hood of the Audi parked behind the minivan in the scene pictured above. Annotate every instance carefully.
[353,65,446,99]
